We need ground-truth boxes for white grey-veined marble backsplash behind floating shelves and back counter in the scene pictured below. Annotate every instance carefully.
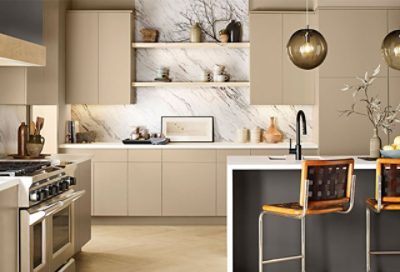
[71,0,313,142]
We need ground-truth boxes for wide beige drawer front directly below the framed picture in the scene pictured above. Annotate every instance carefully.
[163,149,217,162]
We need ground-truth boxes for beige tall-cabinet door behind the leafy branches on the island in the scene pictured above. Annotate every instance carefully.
[319,78,388,155]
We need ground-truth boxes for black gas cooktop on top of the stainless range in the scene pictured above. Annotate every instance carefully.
[0,161,51,177]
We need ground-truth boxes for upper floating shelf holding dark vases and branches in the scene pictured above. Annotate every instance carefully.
[132,42,250,49]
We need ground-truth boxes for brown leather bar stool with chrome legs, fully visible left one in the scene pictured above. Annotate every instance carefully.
[258,159,356,272]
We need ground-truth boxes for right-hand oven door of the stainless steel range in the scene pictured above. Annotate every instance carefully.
[46,191,85,271]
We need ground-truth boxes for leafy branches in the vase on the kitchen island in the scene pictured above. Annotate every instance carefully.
[340,65,400,134]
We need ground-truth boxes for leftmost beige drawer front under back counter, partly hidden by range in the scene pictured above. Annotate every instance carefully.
[60,149,128,162]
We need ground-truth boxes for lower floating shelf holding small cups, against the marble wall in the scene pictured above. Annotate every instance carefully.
[132,81,250,88]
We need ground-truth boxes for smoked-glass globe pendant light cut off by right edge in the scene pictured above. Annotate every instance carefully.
[382,30,400,70]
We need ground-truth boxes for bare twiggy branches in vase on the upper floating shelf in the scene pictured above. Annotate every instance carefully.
[176,0,235,42]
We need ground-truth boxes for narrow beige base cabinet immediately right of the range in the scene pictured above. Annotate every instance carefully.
[74,160,92,254]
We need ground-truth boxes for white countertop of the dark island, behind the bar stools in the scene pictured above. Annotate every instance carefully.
[228,156,376,170]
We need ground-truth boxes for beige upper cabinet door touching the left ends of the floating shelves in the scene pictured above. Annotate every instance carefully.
[99,12,132,105]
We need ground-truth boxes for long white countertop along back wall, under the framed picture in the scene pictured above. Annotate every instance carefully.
[59,142,318,149]
